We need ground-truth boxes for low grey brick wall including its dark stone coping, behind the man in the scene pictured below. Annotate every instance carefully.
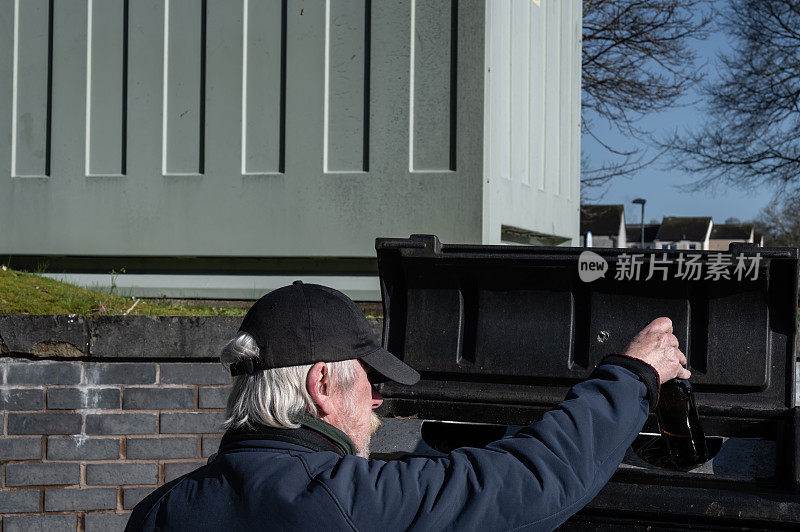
[0,316,390,532]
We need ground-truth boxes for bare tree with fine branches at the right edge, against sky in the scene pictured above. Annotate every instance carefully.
[661,0,800,195]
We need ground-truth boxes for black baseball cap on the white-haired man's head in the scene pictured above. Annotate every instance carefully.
[230,281,419,385]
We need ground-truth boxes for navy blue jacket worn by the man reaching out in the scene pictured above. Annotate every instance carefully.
[126,361,655,532]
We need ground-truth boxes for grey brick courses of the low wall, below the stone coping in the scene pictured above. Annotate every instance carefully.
[0,357,230,531]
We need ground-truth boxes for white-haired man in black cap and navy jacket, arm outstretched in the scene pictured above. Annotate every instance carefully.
[127,281,689,532]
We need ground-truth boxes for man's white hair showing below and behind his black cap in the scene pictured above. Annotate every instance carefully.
[219,332,355,430]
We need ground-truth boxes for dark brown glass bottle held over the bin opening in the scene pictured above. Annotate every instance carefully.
[656,379,708,471]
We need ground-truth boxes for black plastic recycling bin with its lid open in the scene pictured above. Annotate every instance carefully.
[373,235,800,530]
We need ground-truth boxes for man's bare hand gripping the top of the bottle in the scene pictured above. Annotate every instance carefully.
[623,317,692,384]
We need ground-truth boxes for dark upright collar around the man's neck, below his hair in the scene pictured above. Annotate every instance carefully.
[220,412,357,456]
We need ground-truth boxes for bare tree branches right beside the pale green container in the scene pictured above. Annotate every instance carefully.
[581,0,711,187]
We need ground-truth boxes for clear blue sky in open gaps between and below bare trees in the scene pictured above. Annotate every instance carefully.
[581,8,773,223]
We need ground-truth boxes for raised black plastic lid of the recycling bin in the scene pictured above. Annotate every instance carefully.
[375,235,798,423]
